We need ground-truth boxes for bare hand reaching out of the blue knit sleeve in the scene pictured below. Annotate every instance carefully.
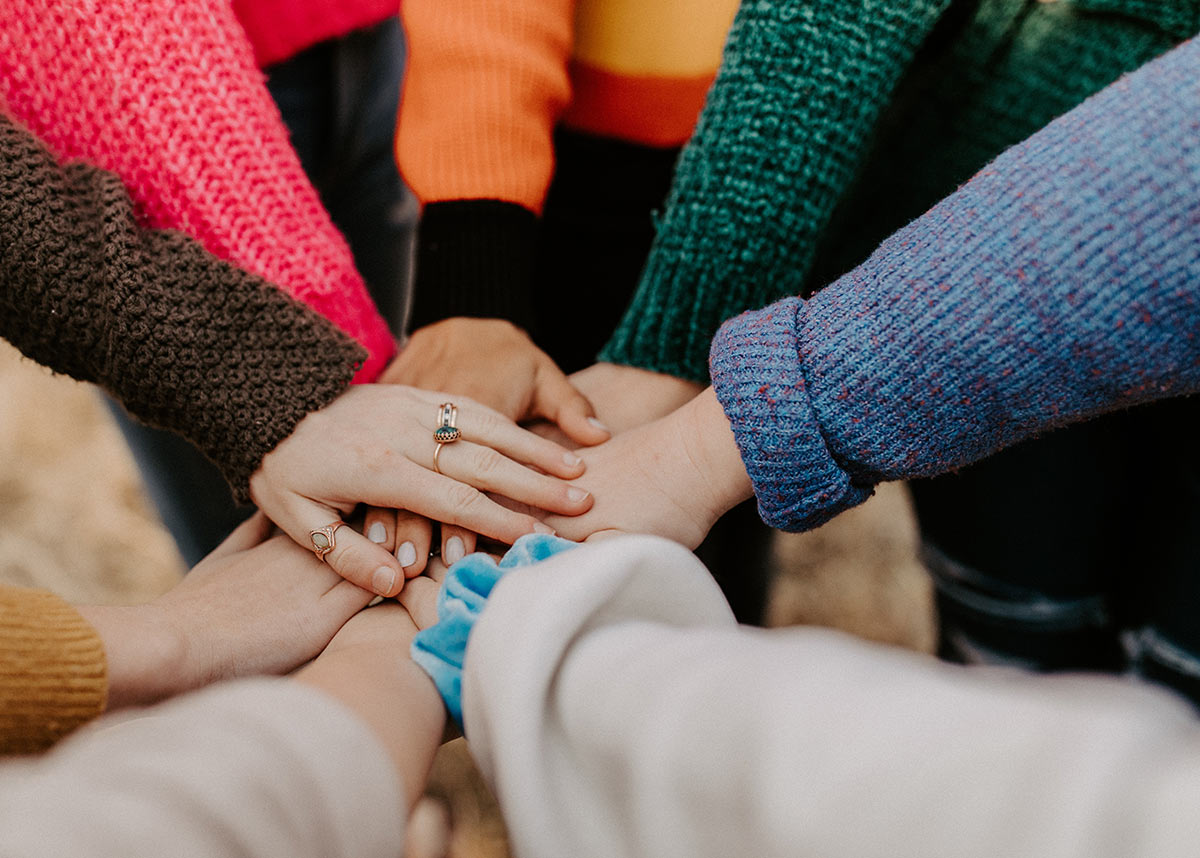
[546,389,752,548]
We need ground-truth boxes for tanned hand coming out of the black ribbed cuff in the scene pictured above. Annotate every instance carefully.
[379,318,610,446]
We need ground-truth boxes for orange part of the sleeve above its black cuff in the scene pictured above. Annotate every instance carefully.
[396,0,575,214]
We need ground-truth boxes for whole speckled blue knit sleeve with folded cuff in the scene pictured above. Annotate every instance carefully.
[710,40,1200,537]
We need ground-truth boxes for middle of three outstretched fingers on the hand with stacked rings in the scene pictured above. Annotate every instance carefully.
[438,440,592,515]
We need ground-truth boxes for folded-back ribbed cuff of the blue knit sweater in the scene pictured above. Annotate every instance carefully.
[709,298,874,530]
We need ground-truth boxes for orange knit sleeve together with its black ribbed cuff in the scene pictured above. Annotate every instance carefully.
[396,0,574,331]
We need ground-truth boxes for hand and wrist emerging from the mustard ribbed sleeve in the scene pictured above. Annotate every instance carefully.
[79,514,371,709]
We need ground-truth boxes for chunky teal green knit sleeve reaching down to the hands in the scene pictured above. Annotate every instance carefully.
[600,0,948,382]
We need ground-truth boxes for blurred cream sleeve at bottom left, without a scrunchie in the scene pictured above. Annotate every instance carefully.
[0,679,404,858]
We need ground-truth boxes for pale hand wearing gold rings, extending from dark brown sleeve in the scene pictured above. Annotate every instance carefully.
[250,384,592,596]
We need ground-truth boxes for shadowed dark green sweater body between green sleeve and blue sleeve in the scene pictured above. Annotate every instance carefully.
[802,0,1200,294]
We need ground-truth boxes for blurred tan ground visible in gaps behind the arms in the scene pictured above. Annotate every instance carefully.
[0,343,934,858]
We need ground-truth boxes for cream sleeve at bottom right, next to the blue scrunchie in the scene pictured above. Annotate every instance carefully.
[463,536,1200,858]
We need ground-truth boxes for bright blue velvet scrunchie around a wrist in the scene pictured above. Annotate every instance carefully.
[412,533,577,728]
